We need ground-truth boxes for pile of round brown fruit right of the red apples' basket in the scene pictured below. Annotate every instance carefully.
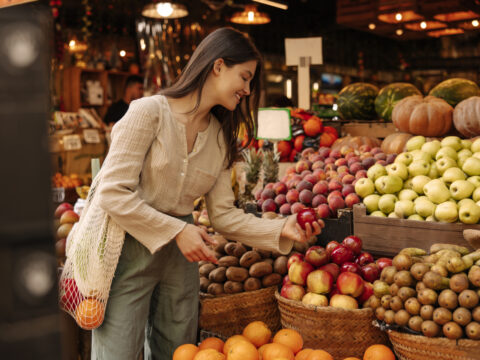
[365,244,480,340]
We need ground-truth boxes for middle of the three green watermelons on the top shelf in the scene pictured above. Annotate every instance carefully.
[375,83,422,121]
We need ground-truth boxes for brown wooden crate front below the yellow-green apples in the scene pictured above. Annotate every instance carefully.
[353,204,480,257]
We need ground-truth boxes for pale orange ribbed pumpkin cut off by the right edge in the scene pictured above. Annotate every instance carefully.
[453,96,480,138]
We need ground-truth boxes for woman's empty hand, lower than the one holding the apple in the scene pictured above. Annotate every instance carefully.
[175,224,218,264]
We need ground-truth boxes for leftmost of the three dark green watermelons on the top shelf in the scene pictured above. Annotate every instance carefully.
[337,83,378,120]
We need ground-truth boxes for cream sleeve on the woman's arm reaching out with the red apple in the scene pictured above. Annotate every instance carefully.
[206,170,293,254]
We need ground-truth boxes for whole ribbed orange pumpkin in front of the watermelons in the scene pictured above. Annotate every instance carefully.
[392,95,453,136]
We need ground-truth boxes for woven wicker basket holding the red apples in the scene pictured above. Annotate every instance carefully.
[275,291,389,359]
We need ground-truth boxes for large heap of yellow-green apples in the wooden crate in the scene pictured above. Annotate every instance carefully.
[355,136,480,224]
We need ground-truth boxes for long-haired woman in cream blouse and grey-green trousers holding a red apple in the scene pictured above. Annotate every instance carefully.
[92,28,321,360]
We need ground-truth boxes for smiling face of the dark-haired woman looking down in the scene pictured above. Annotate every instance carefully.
[217,60,257,111]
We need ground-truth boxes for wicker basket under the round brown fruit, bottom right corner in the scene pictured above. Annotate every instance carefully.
[388,330,480,360]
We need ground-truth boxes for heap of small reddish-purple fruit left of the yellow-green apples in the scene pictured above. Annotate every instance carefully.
[255,145,396,218]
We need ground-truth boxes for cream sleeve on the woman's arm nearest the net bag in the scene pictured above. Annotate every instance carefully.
[98,99,186,253]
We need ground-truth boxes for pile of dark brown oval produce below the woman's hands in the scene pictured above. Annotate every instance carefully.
[198,235,288,295]
